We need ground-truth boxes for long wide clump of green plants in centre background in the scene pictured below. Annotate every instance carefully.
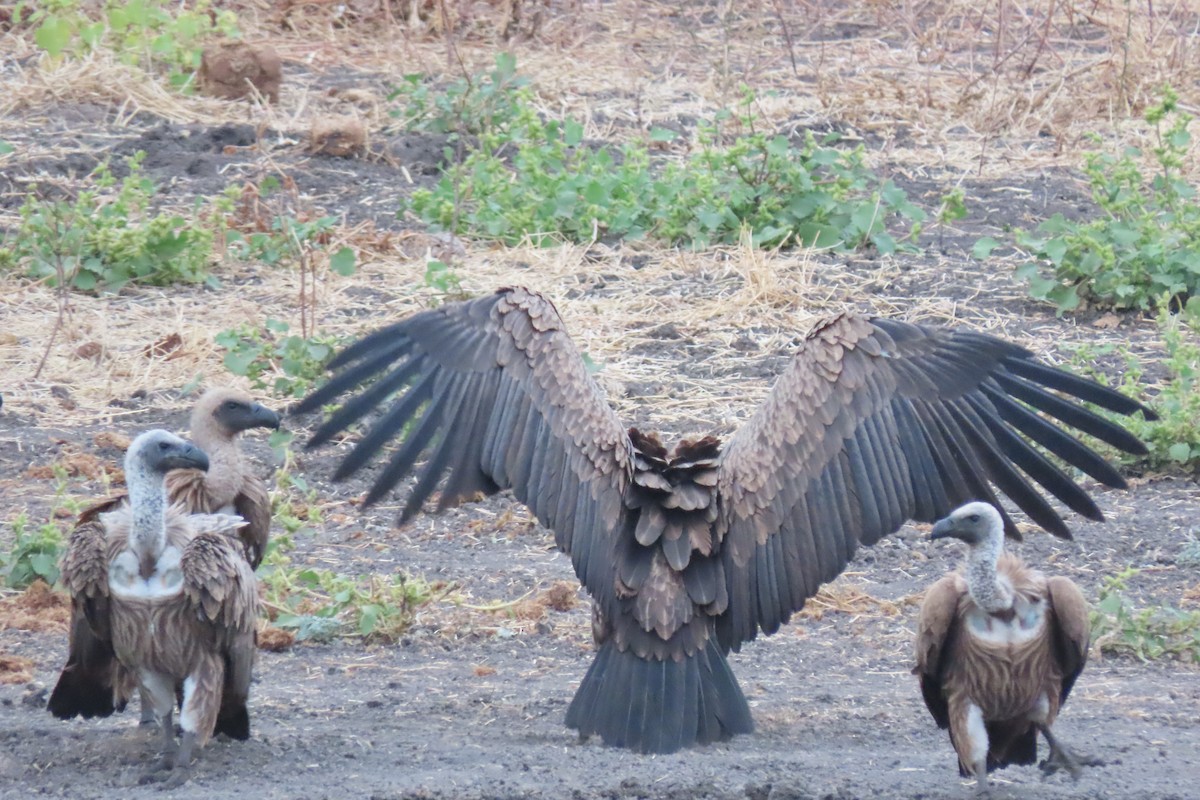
[402,68,925,253]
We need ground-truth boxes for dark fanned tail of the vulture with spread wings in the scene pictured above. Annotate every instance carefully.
[566,638,754,753]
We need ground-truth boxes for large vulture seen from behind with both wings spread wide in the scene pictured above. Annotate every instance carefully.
[296,288,1150,752]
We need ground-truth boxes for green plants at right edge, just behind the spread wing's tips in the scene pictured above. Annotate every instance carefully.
[1072,299,1200,470]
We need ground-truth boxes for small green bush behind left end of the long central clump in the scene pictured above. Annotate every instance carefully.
[388,53,532,137]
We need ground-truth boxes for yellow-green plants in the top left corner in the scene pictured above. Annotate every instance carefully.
[13,0,238,90]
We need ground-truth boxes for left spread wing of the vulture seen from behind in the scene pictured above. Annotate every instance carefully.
[295,289,632,606]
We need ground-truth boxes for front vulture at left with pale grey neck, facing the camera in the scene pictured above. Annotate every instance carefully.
[62,431,259,783]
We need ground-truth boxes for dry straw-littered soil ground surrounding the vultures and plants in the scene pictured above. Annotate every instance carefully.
[0,0,1200,799]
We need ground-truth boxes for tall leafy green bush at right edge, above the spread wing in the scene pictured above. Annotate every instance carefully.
[1015,88,1200,313]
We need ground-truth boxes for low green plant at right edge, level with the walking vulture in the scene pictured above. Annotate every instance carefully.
[1092,567,1200,661]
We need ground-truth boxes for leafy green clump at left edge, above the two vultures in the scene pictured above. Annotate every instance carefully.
[0,152,215,293]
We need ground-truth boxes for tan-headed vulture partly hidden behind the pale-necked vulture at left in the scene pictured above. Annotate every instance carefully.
[48,389,280,724]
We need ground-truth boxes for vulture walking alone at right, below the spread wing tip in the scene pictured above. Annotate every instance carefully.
[913,503,1098,794]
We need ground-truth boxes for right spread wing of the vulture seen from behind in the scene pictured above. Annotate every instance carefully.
[718,314,1152,648]
